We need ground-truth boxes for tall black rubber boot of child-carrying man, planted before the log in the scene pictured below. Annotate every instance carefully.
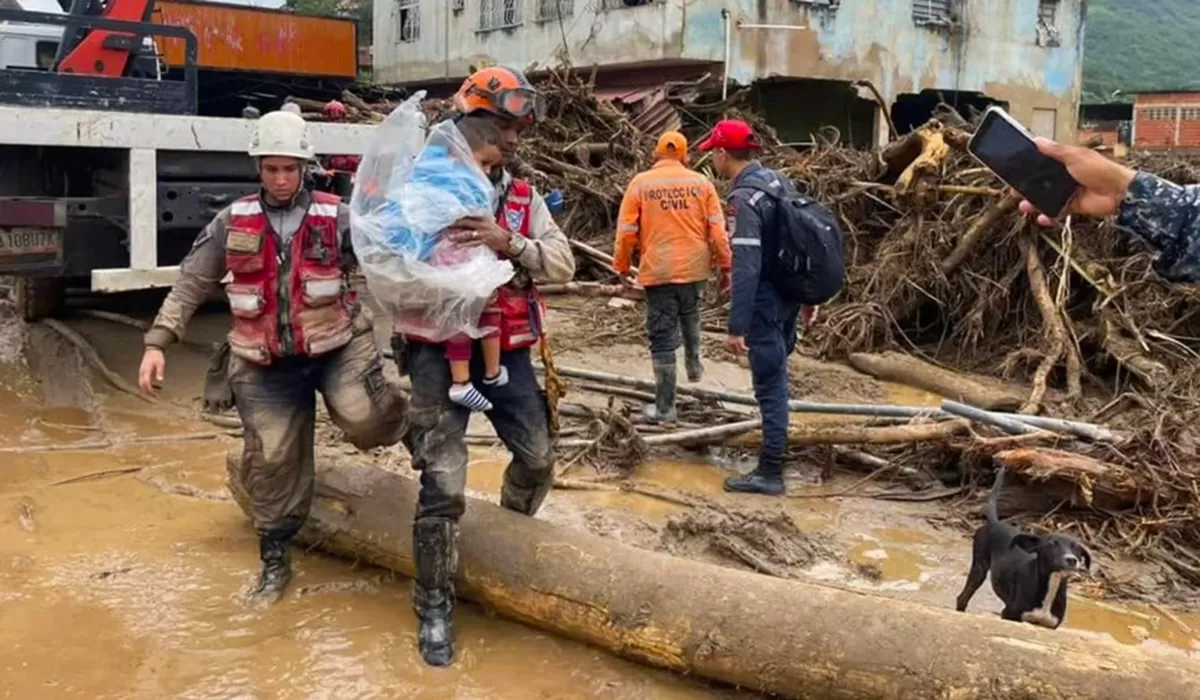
[413,517,458,666]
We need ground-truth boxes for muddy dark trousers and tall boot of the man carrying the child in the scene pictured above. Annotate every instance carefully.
[394,341,554,666]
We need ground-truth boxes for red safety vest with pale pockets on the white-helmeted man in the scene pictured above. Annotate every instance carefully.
[226,192,358,365]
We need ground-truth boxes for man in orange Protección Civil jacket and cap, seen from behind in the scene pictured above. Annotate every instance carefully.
[613,131,732,420]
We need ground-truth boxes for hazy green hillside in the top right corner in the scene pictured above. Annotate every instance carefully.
[1084,0,1200,102]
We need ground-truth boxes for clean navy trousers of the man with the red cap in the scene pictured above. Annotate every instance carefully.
[746,282,800,475]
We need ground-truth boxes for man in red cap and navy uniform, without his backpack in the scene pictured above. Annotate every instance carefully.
[696,119,811,496]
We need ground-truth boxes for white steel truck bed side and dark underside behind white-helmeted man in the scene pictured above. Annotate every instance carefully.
[0,106,373,292]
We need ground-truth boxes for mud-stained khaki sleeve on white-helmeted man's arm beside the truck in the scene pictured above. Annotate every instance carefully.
[144,208,229,348]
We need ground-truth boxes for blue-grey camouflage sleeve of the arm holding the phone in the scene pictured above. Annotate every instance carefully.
[1117,173,1200,282]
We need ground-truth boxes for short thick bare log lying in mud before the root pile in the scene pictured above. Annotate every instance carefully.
[850,353,1027,411]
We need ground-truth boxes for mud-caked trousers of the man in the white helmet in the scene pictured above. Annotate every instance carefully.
[229,329,406,542]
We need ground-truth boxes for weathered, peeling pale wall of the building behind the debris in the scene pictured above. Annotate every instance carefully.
[374,0,1086,139]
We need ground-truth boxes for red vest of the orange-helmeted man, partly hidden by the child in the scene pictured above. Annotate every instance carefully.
[397,179,546,352]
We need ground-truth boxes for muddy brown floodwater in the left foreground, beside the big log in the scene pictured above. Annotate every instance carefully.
[0,445,734,699]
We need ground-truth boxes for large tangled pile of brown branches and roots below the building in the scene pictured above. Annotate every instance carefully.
[324,71,1200,585]
